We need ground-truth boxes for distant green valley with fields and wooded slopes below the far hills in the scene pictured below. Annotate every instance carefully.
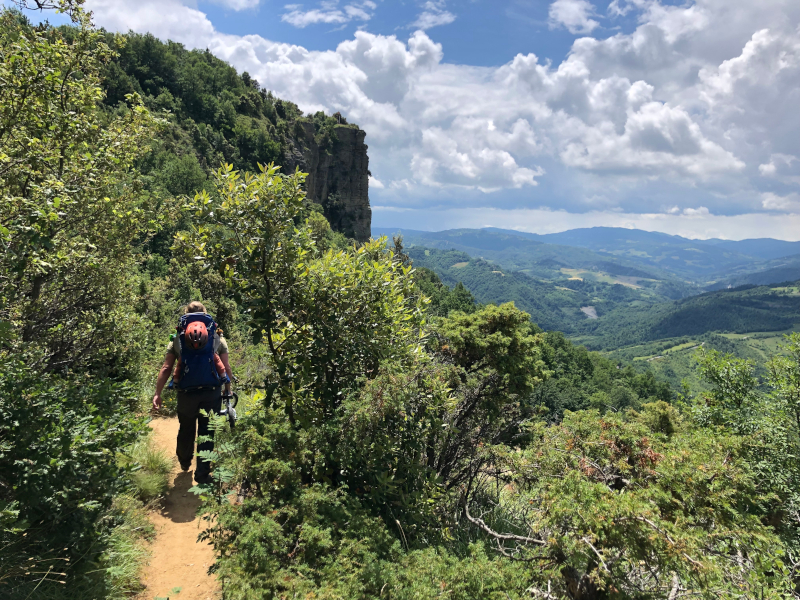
[408,244,800,390]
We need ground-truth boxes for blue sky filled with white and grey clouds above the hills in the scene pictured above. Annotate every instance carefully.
[26,0,800,239]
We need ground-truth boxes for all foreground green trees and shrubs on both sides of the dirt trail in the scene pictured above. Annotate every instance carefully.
[0,2,800,600]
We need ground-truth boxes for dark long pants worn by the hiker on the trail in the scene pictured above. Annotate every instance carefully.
[175,387,222,476]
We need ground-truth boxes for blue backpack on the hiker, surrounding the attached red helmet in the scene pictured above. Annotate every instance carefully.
[173,313,224,391]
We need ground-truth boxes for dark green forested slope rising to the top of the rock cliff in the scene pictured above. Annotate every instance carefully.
[100,25,357,250]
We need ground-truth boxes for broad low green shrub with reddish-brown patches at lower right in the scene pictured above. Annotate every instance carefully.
[472,404,791,600]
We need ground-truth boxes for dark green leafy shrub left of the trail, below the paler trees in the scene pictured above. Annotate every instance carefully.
[0,361,144,591]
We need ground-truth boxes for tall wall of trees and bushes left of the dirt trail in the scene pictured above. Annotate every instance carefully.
[0,9,176,600]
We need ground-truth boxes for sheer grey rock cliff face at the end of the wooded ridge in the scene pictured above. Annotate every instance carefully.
[283,121,372,242]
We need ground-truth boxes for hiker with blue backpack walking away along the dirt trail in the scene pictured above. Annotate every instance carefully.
[153,302,233,483]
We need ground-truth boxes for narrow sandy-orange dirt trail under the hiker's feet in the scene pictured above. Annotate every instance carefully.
[139,418,219,600]
